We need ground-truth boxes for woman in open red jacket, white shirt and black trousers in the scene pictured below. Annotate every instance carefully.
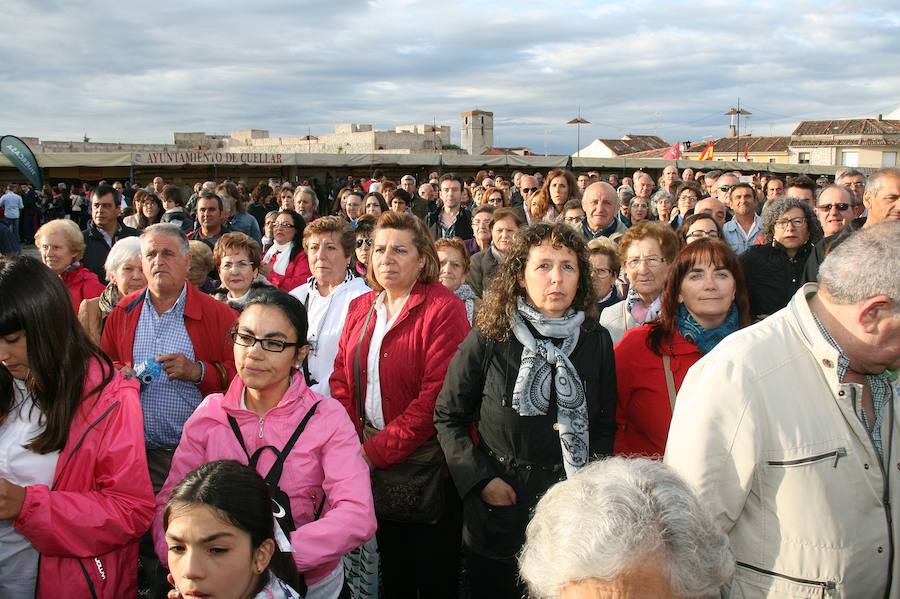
[330,212,469,599]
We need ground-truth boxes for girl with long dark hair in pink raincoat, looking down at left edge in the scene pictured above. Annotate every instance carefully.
[0,257,153,599]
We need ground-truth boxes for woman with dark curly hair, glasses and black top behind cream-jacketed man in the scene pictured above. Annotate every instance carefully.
[741,197,822,320]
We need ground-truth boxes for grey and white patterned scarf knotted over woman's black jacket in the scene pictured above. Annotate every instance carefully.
[510,297,588,477]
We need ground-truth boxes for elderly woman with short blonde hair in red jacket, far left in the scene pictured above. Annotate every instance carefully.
[34,218,106,314]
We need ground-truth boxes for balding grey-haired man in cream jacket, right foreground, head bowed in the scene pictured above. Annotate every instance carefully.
[665,223,900,598]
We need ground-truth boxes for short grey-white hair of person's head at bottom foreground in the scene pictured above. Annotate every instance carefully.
[519,457,734,599]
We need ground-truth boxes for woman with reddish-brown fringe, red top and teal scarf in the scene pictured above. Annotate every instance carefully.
[615,239,750,457]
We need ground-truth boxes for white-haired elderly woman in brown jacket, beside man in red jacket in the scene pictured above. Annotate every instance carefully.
[78,237,147,345]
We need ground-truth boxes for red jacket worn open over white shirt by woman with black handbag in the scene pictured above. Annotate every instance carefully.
[330,283,470,469]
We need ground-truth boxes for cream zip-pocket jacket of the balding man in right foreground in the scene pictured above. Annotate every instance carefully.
[665,284,900,599]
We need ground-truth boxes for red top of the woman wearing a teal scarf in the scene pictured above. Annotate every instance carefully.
[613,325,701,457]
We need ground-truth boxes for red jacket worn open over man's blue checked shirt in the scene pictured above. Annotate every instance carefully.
[100,283,238,396]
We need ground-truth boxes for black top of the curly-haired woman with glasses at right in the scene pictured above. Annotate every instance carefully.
[739,241,813,320]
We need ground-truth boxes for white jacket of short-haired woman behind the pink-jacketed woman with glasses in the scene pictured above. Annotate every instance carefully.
[291,277,372,397]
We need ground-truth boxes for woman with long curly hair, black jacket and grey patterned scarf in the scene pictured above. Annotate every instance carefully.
[434,223,616,598]
